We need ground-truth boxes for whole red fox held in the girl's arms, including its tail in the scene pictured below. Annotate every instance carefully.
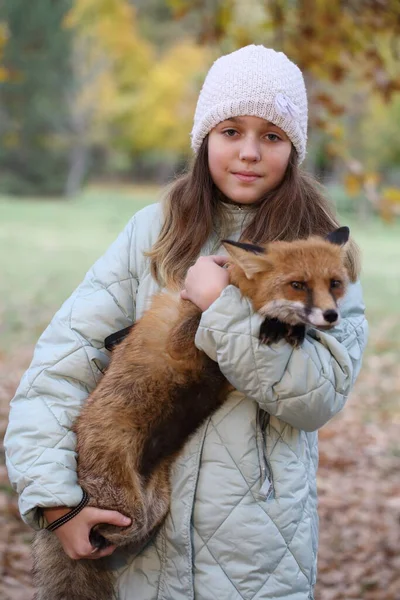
[33,227,357,600]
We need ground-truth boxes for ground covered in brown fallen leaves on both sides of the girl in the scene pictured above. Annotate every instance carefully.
[0,340,400,600]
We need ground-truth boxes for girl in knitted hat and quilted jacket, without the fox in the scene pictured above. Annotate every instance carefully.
[6,46,366,600]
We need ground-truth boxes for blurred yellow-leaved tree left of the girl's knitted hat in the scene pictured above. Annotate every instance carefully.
[65,0,209,185]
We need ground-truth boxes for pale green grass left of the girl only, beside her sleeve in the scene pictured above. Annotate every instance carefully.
[0,188,157,352]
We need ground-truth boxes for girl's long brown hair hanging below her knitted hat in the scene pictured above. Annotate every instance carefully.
[147,136,359,289]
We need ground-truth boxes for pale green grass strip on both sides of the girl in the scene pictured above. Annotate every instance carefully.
[0,187,400,352]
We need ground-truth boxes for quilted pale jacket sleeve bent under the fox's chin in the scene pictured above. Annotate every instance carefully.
[196,283,367,431]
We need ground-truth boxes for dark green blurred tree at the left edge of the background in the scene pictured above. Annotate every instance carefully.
[0,0,72,195]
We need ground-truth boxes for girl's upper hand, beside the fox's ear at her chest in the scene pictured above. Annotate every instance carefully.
[181,256,229,312]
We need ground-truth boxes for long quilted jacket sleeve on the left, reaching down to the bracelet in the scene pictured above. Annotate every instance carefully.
[5,218,138,527]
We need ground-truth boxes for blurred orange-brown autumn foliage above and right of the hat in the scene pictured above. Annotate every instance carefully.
[168,0,400,108]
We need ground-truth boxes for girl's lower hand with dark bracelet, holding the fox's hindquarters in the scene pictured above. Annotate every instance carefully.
[43,506,131,560]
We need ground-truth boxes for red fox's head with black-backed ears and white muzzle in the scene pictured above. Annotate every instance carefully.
[223,227,350,329]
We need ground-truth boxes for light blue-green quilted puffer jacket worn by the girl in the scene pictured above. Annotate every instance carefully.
[5,205,367,600]
